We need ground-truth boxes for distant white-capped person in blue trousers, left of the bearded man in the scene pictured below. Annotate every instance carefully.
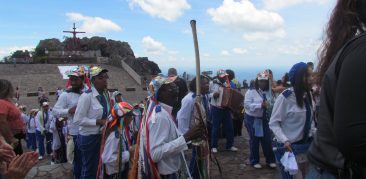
[36,102,53,160]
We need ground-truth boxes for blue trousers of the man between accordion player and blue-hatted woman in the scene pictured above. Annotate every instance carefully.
[244,113,276,165]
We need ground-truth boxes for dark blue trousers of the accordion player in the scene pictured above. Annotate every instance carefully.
[211,106,234,149]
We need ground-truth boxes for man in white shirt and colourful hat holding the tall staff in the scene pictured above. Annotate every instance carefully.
[139,77,203,178]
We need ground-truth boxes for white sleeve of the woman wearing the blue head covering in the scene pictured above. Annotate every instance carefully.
[269,95,288,143]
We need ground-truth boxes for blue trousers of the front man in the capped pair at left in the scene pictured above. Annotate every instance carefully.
[77,134,102,179]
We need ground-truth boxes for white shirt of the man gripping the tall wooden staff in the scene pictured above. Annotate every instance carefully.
[143,103,188,175]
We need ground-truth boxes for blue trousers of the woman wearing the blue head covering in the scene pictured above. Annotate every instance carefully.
[274,142,310,179]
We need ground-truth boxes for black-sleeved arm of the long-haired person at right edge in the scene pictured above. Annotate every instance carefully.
[334,46,366,165]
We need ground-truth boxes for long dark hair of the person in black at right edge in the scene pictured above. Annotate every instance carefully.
[316,0,366,84]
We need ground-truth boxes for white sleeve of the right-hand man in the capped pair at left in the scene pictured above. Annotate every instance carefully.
[74,93,97,126]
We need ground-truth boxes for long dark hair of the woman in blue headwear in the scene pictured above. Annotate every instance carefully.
[293,68,310,108]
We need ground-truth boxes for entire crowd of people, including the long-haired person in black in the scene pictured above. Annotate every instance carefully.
[0,0,366,179]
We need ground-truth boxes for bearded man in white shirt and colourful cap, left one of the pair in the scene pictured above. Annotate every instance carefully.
[52,68,85,178]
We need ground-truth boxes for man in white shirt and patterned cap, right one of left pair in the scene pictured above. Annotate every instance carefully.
[74,66,111,179]
